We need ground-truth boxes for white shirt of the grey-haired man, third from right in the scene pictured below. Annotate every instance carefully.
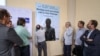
[64,27,73,45]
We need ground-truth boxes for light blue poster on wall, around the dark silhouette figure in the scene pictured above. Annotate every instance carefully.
[35,3,60,39]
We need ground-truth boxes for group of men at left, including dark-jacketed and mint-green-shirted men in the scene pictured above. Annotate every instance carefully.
[0,8,32,56]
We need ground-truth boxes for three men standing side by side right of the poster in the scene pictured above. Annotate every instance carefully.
[63,20,100,56]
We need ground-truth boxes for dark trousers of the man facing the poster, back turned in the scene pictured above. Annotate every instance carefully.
[38,41,47,56]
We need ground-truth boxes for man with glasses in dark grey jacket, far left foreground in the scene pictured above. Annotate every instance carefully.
[0,8,23,56]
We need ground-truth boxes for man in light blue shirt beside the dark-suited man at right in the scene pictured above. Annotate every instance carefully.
[75,21,86,56]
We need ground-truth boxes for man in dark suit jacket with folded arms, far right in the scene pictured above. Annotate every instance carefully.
[81,20,100,56]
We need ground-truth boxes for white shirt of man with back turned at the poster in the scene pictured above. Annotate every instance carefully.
[35,29,45,44]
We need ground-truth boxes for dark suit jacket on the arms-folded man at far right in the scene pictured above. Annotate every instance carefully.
[81,29,100,56]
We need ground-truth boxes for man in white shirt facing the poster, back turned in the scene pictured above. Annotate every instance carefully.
[35,25,47,56]
